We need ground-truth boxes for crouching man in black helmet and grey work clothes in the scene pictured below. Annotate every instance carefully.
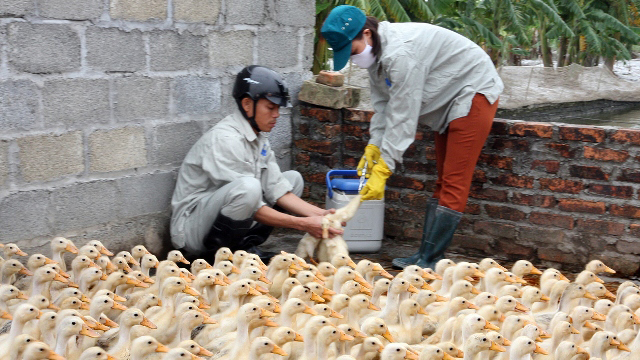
[171,65,342,262]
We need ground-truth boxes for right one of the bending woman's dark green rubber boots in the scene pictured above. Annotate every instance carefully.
[416,205,462,269]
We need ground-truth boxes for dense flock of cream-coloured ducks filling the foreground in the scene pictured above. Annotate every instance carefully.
[0,237,640,360]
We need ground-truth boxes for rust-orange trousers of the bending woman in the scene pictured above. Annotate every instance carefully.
[433,93,498,212]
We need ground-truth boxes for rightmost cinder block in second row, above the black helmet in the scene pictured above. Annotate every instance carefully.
[258,31,298,68]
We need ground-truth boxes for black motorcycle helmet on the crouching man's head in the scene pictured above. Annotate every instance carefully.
[233,65,290,132]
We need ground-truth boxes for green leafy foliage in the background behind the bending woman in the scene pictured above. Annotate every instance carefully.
[313,0,640,73]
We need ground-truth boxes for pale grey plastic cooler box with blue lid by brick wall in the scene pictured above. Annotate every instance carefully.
[325,170,384,253]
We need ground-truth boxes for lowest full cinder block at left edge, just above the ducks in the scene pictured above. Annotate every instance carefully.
[0,190,51,243]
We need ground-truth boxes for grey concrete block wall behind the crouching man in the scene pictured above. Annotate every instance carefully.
[0,0,315,254]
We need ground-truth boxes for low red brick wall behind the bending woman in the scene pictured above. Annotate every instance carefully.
[293,106,640,275]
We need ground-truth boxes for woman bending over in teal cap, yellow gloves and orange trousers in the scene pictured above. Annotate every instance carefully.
[322,5,503,268]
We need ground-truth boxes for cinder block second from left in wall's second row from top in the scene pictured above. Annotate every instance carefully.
[86,27,146,72]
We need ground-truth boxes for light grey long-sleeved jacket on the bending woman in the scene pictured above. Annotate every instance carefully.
[369,21,504,171]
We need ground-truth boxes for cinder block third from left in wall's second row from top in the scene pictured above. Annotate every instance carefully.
[150,31,207,71]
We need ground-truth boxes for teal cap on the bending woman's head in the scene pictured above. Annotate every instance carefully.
[320,5,367,71]
